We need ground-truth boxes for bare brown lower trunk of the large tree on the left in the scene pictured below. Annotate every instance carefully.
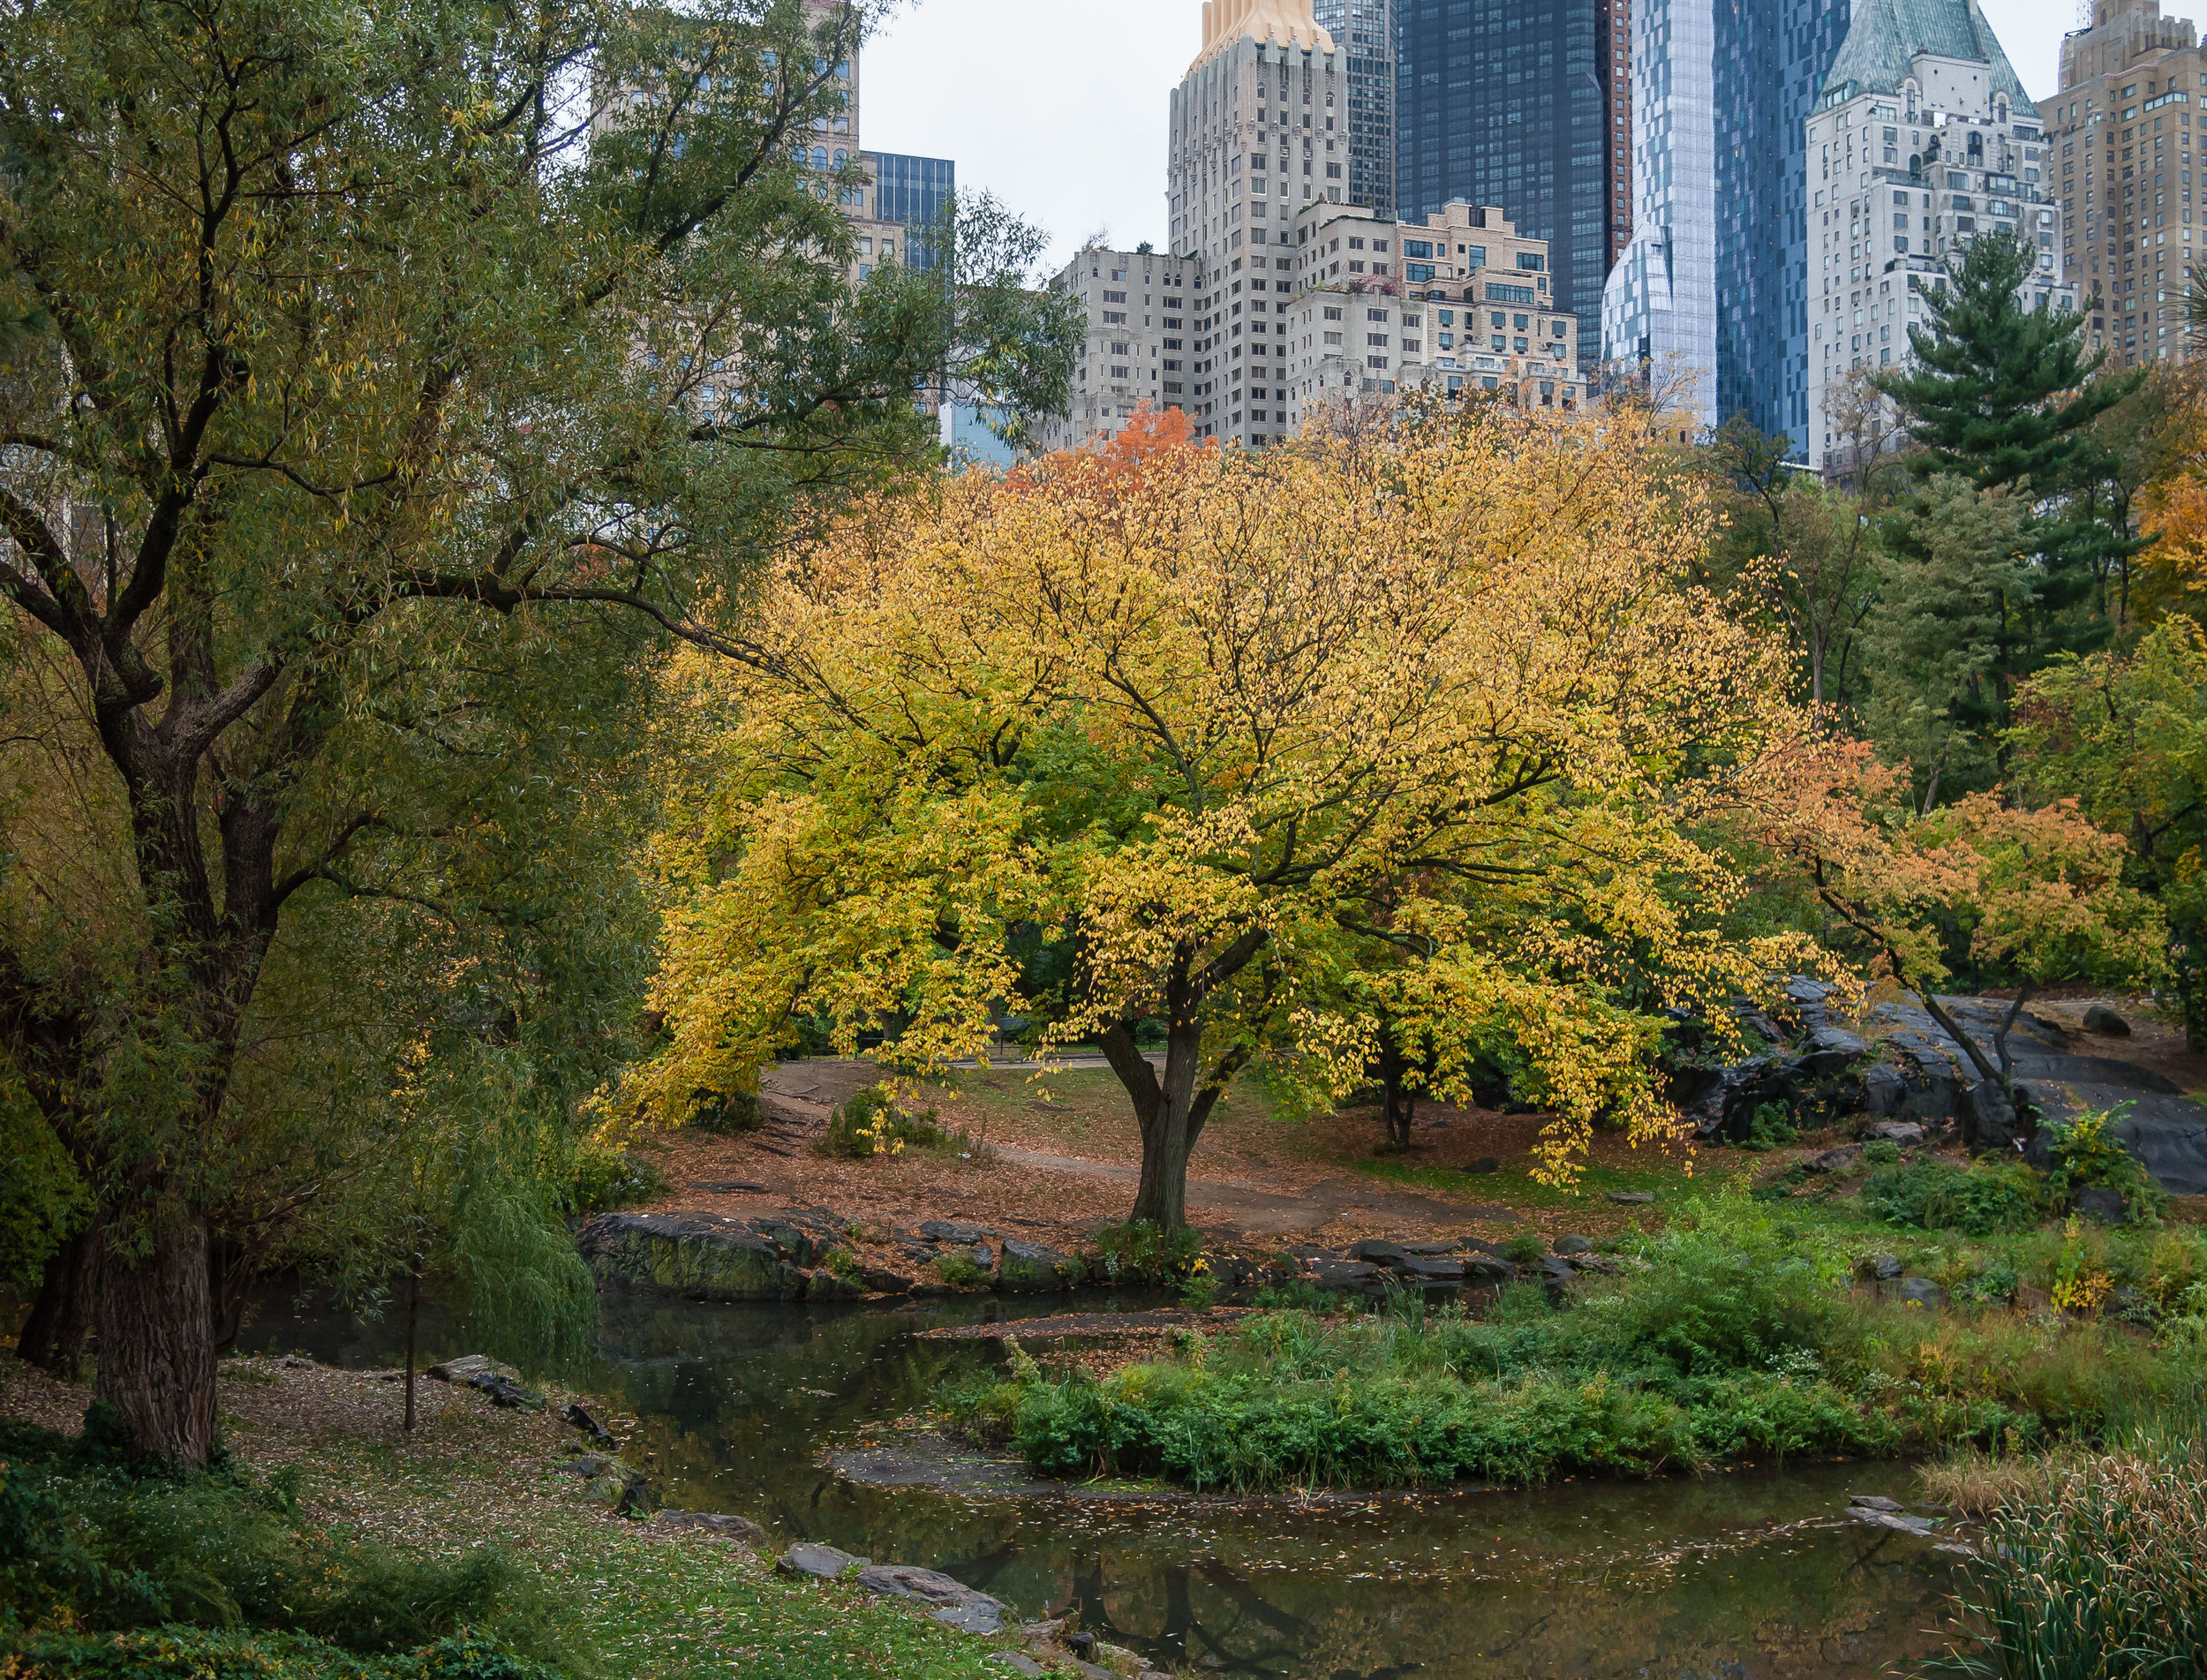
[100,1203,215,1470]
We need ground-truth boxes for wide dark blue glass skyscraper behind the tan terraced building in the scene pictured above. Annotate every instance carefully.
[1395,0,1629,356]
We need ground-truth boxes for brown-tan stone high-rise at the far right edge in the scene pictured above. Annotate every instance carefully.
[2042,0,2207,366]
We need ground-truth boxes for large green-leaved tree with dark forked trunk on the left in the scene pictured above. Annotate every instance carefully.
[0,0,1071,1464]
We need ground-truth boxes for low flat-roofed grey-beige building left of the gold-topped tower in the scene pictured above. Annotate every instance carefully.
[1040,250,1201,450]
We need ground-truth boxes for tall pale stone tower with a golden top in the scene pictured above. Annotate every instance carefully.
[1168,0,1349,444]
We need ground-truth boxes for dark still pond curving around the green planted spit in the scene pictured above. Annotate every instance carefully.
[245,1296,1954,1680]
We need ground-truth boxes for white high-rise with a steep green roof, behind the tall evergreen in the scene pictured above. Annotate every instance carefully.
[1808,0,2077,471]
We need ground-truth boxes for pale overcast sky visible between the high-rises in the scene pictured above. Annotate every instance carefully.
[861,0,2136,267]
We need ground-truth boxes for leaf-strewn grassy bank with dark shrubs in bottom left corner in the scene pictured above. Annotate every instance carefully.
[0,1408,1024,1680]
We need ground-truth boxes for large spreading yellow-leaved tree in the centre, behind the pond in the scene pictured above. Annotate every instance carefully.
[631,413,1819,1227]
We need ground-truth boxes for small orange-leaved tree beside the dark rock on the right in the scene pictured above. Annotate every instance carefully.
[1757,742,2166,1112]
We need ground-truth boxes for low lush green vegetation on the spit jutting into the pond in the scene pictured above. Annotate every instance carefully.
[945,1190,2198,1490]
